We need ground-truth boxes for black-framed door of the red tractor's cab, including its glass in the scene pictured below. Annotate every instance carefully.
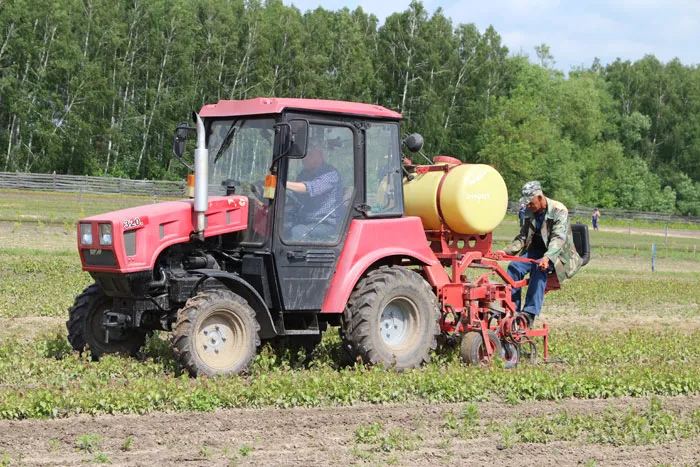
[273,120,362,310]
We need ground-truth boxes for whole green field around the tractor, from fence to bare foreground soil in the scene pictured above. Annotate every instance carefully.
[0,190,700,419]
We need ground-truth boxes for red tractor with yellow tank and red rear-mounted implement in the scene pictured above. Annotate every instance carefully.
[66,98,587,376]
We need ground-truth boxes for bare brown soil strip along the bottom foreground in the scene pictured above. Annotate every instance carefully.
[0,396,700,466]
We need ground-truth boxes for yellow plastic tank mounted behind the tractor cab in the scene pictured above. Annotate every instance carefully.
[403,157,508,234]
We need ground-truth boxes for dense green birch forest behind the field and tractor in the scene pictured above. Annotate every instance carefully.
[0,0,700,216]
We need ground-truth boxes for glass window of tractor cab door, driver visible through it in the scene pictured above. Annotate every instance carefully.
[282,124,355,243]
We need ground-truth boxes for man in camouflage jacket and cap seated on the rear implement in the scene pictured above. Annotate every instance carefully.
[496,181,582,326]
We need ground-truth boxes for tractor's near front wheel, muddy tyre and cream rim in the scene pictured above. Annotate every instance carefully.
[171,289,260,376]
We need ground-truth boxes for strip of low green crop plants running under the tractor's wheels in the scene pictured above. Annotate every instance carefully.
[0,331,700,419]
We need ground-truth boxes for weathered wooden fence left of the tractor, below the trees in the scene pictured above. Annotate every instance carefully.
[0,172,185,198]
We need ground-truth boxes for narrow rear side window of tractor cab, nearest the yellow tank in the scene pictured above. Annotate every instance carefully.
[365,123,403,217]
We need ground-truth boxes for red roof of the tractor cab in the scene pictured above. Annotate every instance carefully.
[199,97,401,120]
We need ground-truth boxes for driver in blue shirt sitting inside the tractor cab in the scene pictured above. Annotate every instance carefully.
[285,145,342,241]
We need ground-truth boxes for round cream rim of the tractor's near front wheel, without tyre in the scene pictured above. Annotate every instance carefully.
[196,310,248,370]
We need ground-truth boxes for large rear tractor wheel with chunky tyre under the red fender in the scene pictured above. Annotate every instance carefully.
[341,266,440,371]
